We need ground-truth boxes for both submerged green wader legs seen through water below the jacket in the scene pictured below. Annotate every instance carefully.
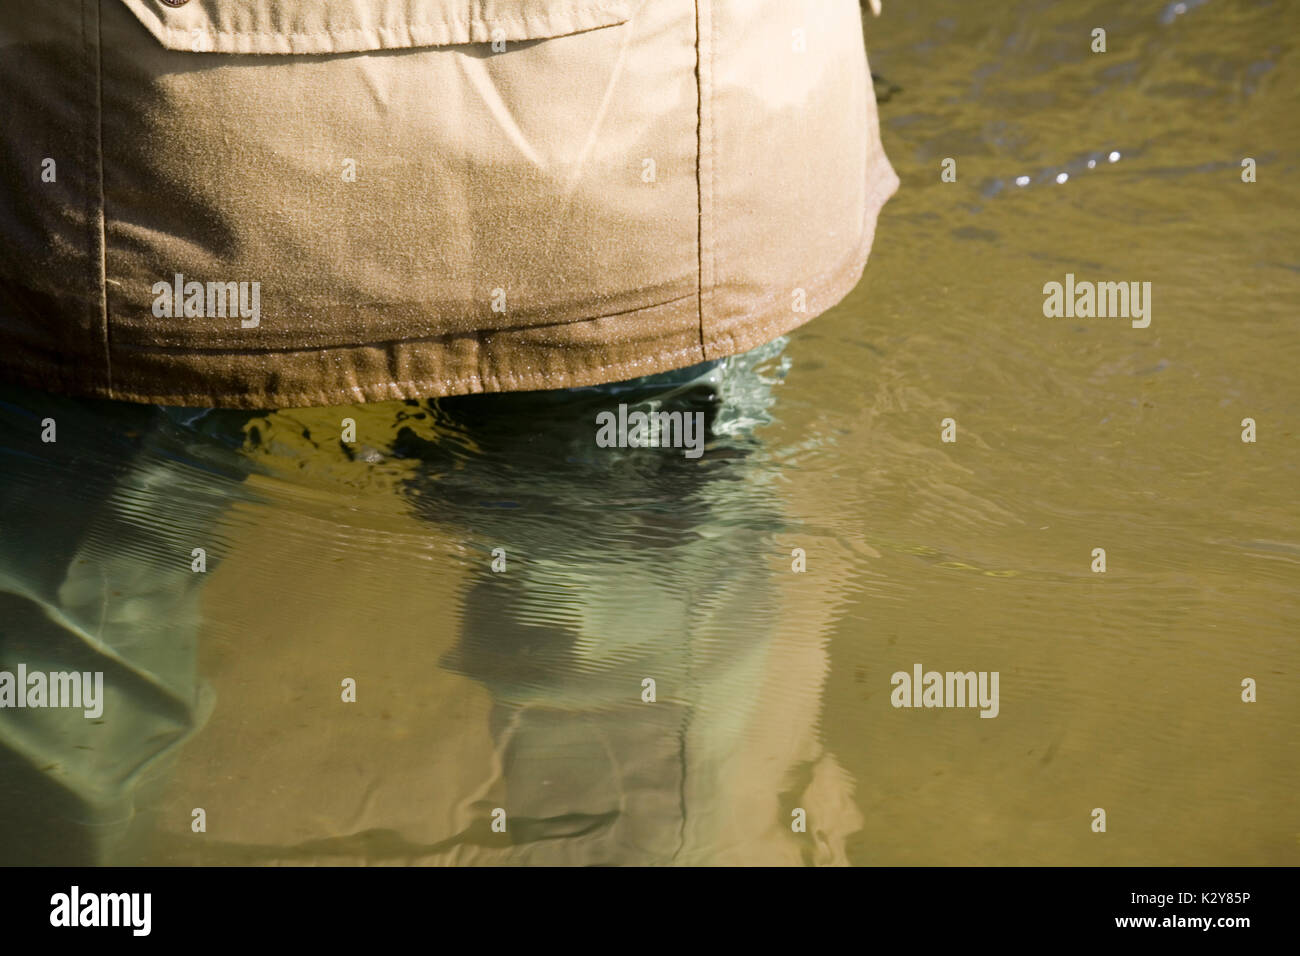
[0,341,857,864]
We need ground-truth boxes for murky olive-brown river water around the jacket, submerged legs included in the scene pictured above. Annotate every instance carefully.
[0,0,1300,865]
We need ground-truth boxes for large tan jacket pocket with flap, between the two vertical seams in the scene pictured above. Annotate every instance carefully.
[100,0,698,351]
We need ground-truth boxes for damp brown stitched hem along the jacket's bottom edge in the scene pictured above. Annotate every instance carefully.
[0,197,897,408]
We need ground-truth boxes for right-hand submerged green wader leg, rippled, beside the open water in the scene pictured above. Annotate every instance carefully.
[393,341,855,864]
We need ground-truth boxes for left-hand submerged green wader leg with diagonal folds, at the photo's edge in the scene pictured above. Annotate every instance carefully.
[0,389,247,864]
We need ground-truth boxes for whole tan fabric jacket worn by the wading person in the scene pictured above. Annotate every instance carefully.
[0,0,897,407]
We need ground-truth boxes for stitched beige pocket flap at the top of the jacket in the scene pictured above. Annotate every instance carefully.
[122,0,636,53]
